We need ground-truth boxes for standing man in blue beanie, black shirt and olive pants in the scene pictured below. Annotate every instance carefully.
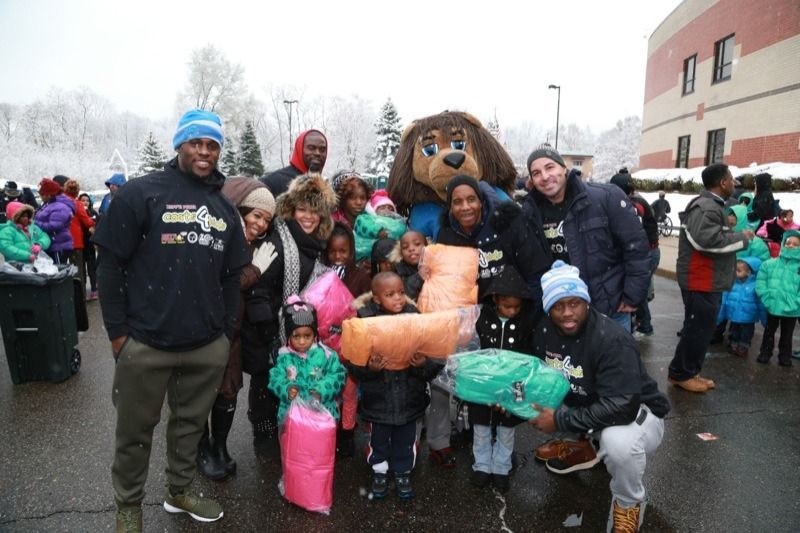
[93,109,250,533]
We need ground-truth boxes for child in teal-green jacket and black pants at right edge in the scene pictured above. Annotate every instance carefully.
[756,230,800,366]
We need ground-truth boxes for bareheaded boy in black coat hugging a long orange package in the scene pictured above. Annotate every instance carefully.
[347,272,441,499]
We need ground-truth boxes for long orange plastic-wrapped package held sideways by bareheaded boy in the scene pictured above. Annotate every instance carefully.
[342,305,480,370]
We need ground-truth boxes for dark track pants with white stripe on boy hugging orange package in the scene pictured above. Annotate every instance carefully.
[367,420,417,473]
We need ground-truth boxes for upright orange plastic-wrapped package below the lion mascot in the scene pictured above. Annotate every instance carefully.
[417,244,478,313]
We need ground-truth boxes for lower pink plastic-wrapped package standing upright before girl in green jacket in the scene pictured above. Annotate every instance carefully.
[280,397,336,514]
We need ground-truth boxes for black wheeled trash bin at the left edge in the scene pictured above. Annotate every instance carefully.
[0,266,81,384]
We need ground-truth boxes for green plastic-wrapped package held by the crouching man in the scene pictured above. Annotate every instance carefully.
[454,349,569,420]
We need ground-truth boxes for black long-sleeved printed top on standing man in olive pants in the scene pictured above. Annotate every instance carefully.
[92,159,250,351]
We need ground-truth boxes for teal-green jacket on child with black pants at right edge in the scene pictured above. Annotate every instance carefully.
[756,230,800,317]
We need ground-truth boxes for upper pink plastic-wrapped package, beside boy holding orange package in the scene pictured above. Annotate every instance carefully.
[301,271,356,354]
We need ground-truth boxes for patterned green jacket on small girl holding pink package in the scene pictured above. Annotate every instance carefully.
[268,342,345,424]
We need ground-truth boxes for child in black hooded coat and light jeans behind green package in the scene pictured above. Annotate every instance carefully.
[467,265,542,492]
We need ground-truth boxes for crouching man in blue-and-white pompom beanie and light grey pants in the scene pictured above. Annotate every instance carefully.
[530,261,670,531]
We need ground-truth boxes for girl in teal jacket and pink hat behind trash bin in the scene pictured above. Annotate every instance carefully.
[0,202,50,263]
